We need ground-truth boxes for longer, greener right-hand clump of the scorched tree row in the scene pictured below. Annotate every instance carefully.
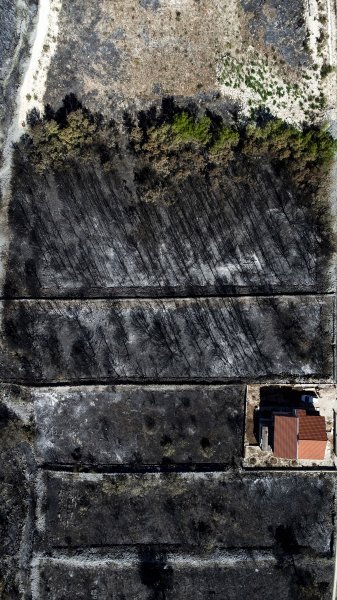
[131,106,337,189]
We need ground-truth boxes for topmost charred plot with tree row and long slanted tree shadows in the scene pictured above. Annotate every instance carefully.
[5,97,335,298]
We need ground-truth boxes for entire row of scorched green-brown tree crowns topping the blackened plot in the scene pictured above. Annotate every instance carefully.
[26,102,337,199]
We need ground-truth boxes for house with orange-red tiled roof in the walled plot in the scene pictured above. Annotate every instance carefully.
[274,410,327,460]
